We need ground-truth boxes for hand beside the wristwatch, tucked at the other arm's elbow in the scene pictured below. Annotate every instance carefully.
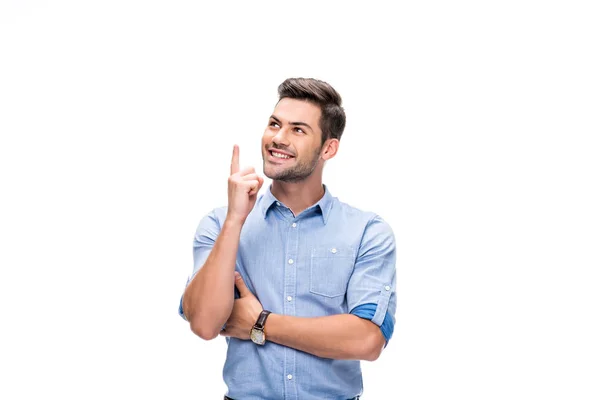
[220,272,263,340]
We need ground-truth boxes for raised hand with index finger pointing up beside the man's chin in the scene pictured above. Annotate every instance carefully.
[227,145,264,224]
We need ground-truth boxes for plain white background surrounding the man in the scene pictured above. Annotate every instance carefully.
[0,0,600,400]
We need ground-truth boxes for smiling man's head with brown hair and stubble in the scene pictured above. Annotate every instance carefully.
[262,78,346,182]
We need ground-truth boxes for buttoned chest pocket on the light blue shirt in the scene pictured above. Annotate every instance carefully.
[310,246,356,297]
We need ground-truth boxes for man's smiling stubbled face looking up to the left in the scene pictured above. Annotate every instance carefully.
[262,98,322,182]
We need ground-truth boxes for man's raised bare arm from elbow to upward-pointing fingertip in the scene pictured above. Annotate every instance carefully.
[183,146,263,340]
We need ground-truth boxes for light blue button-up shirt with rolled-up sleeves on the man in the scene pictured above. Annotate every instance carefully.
[179,185,396,400]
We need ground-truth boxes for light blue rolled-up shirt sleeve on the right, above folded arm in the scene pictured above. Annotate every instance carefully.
[347,216,396,334]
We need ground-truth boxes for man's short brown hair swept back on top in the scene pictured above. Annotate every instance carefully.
[278,78,346,144]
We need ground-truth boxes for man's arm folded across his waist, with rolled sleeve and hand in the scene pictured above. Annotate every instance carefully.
[221,216,396,360]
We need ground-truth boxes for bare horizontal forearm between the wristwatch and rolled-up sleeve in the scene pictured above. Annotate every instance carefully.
[265,314,385,361]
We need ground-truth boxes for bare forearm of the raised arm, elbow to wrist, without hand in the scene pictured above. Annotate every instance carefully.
[183,219,243,340]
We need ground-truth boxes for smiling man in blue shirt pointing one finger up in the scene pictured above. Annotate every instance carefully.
[179,78,396,400]
